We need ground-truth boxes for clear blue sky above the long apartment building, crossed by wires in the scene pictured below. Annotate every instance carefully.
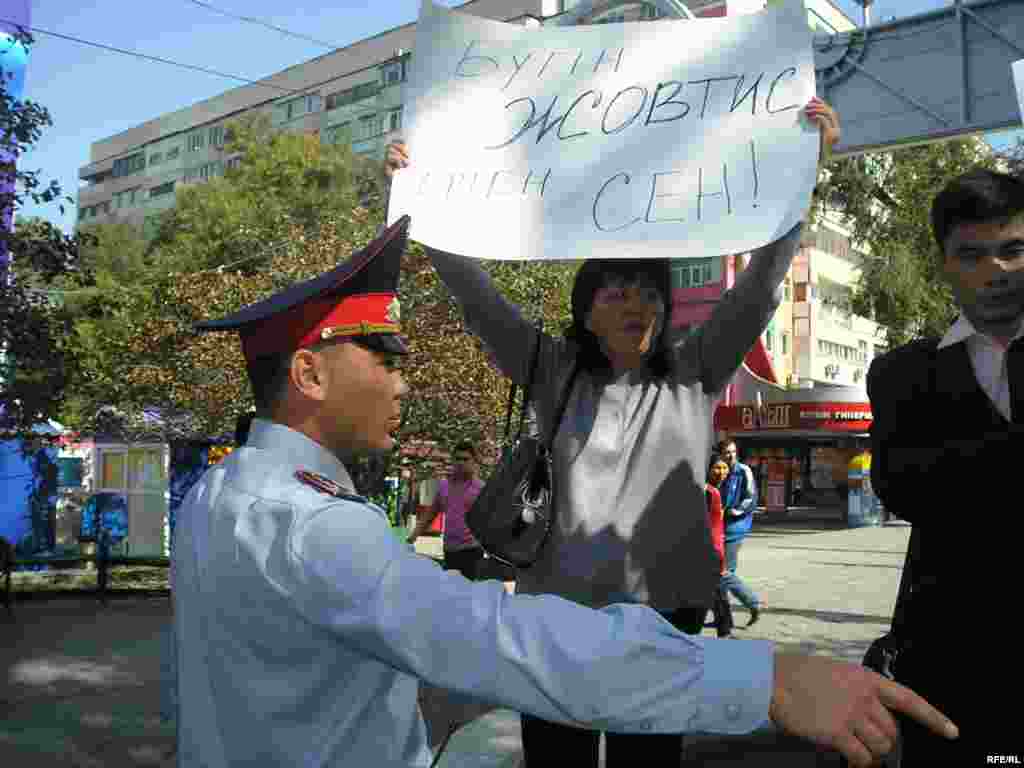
[9,0,1024,231]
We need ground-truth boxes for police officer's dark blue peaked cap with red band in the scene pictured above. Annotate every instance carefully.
[196,216,410,360]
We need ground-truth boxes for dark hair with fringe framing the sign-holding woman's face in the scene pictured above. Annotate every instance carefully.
[565,259,672,377]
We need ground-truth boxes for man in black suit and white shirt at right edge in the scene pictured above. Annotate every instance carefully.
[867,170,1024,768]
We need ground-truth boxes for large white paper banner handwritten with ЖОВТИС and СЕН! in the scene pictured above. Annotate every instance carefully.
[389,0,818,259]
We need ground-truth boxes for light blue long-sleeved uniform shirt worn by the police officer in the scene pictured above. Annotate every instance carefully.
[173,420,772,768]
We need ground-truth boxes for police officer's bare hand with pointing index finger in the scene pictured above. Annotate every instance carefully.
[768,653,958,768]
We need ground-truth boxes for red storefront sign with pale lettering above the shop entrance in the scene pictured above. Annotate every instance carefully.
[715,402,871,432]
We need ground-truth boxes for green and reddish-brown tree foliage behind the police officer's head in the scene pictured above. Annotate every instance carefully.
[66,123,574,487]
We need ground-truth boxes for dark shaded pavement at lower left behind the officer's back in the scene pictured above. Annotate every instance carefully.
[0,597,174,768]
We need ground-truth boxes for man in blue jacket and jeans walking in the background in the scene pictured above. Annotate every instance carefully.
[718,439,762,627]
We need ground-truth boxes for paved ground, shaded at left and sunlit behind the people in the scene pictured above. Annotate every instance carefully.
[0,519,909,768]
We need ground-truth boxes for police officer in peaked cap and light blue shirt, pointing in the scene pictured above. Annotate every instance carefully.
[174,217,953,768]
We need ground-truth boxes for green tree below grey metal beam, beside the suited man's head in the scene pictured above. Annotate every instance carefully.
[816,137,998,346]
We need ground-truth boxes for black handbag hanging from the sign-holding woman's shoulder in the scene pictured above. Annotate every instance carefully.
[466,326,575,568]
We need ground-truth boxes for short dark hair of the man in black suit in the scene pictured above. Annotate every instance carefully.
[932,168,1024,256]
